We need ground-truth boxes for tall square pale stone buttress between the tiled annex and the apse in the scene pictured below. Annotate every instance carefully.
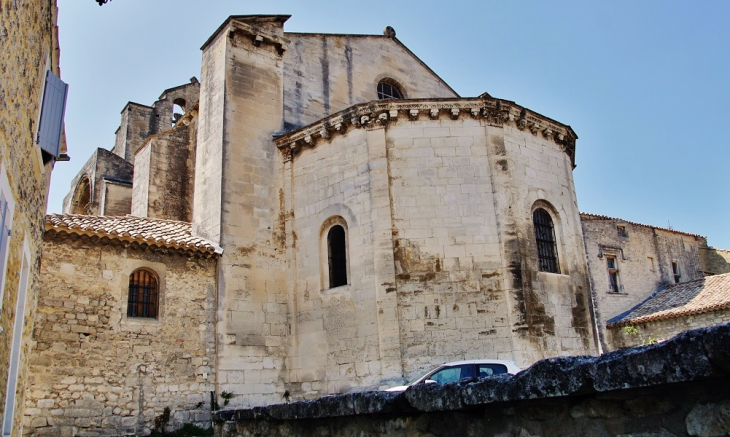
[193,17,289,405]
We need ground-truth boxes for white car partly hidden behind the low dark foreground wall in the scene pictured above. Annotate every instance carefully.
[386,360,522,391]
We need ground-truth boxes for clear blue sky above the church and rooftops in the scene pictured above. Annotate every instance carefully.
[54,0,730,248]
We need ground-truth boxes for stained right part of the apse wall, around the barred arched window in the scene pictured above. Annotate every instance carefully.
[387,120,593,375]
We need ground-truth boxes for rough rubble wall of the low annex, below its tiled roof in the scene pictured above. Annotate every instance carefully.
[24,235,216,436]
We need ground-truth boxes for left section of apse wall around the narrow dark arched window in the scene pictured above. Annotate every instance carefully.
[285,129,386,396]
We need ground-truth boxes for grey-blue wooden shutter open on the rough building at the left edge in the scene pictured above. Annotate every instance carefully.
[36,70,68,158]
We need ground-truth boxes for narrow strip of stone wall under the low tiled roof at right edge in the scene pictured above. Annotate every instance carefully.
[607,308,730,350]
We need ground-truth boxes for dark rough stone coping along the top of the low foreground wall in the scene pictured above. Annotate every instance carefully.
[213,323,730,421]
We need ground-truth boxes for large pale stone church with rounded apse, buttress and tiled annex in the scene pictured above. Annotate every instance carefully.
[26,15,724,435]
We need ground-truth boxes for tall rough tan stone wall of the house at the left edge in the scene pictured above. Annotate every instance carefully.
[0,0,65,436]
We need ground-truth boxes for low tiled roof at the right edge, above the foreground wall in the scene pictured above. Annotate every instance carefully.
[607,273,730,327]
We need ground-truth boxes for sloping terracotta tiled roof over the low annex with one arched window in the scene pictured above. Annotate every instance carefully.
[46,214,223,254]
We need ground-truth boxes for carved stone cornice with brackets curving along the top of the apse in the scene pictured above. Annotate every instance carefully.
[275,97,578,167]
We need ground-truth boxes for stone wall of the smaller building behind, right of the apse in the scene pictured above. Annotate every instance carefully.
[581,215,707,350]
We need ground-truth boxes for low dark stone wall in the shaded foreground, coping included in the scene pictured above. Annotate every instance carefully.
[214,324,730,437]
